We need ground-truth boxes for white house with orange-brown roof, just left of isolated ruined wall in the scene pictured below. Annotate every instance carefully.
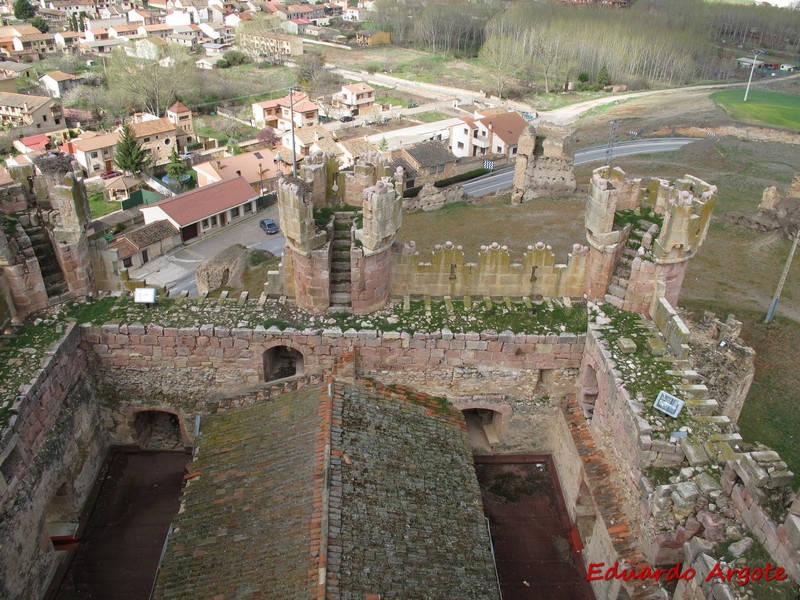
[450,111,528,158]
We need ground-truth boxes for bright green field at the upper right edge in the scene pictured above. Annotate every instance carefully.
[711,89,800,130]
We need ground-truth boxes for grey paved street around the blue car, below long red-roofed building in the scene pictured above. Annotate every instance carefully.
[131,204,286,297]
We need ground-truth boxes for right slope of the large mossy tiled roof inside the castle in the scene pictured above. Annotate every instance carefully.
[327,383,496,599]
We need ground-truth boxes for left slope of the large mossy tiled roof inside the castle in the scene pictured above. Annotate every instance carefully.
[155,386,324,600]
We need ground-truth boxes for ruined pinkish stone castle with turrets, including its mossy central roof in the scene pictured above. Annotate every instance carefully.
[0,129,800,599]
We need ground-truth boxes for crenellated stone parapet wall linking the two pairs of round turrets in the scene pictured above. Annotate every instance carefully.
[392,242,588,298]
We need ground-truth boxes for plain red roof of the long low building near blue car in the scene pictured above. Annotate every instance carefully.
[142,177,258,227]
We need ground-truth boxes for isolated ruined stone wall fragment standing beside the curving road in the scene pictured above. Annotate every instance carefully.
[511,123,577,204]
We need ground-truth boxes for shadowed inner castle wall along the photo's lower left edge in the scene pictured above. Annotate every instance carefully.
[0,325,108,598]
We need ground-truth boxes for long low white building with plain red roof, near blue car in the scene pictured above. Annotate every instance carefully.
[141,177,259,243]
